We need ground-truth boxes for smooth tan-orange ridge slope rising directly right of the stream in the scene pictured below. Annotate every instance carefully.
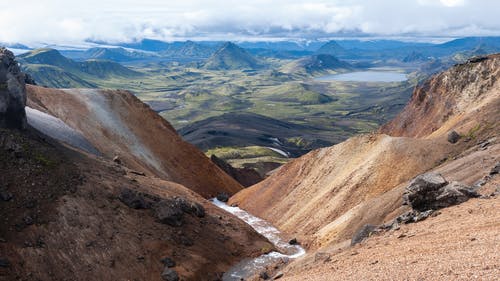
[230,135,451,247]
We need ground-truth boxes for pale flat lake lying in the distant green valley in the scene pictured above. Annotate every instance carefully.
[314,71,407,82]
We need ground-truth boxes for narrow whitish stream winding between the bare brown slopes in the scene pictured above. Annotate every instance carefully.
[211,198,306,281]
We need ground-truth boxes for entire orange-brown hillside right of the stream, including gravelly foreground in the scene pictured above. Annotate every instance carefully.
[229,55,500,280]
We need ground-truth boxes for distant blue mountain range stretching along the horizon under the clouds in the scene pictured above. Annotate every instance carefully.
[5,37,500,64]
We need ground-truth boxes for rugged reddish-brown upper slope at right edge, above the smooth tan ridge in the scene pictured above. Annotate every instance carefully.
[380,54,500,138]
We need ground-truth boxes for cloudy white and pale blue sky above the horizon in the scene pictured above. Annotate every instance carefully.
[0,0,500,44]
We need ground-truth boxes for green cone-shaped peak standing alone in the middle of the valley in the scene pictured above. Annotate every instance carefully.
[203,42,263,70]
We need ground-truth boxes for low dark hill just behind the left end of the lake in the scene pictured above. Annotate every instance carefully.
[281,54,352,75]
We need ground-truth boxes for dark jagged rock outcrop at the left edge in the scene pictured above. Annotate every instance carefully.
[0,48,27,129]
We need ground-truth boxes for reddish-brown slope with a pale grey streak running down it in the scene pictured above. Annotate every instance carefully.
[27,86,242,198]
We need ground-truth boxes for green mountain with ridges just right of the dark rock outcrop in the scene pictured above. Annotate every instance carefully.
[18,49,142,88]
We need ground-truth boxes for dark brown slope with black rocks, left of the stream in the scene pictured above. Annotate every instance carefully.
[0,127,271,280]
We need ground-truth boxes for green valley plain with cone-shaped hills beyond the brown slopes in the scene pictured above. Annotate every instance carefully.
[20,46,418,167]
